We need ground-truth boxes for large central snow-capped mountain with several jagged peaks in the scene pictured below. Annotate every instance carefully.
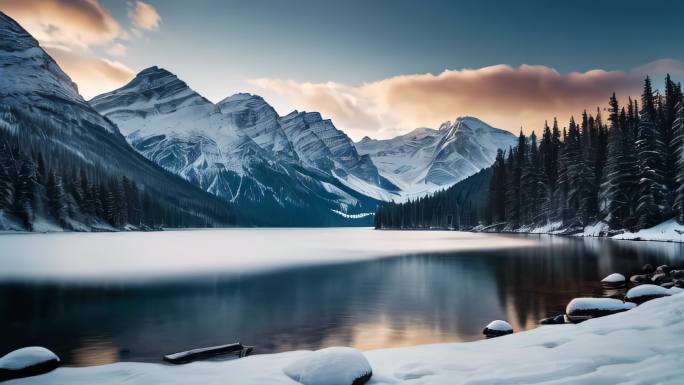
[90,67,384,225]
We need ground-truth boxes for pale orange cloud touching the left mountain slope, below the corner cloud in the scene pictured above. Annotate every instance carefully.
[46,47,135,99]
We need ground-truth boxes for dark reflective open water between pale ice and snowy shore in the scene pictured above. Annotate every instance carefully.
[0,229,684,366]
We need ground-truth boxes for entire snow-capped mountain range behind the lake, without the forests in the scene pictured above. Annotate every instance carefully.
[0,14,515,226]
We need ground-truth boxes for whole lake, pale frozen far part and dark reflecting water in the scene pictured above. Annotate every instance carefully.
[0,228,684,366]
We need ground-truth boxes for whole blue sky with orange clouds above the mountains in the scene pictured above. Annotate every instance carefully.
[0,0,684,140]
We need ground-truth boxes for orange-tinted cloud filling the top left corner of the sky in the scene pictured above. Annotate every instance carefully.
[2,0,122,49]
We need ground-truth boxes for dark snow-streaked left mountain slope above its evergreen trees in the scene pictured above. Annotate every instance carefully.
[0,12,235,226]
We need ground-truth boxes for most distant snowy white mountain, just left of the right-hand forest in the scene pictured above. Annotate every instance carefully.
[356,116,516,198]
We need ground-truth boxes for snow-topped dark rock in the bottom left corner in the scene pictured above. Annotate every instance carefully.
[0,346,59,381]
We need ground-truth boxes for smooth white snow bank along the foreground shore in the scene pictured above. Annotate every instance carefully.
[7,294,684,385]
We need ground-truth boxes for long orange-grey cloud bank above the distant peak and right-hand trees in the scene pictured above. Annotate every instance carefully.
[250,59,684,139]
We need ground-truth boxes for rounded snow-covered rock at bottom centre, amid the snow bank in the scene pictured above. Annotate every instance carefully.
[283,347,373,385]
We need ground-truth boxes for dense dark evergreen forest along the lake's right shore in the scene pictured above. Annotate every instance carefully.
[375,75,684,231]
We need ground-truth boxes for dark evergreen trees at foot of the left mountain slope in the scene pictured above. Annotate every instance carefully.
[0,109,235,231]
